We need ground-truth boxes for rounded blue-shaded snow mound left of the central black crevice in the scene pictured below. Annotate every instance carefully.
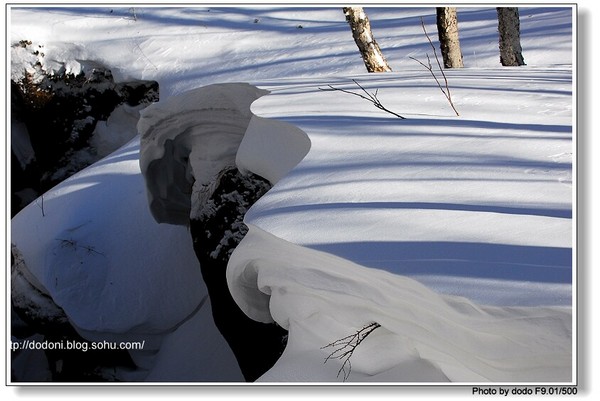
[11,140,206,336]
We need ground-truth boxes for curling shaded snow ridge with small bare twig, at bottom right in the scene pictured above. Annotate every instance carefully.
[227,224,572,382]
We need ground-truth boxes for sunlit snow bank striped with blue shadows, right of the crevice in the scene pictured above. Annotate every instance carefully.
[240,68,574,306]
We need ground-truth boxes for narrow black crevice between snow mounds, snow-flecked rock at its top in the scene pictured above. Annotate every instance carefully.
[190,167,287,381]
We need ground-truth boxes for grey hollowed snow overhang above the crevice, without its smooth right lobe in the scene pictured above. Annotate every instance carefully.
[138,84,268,225]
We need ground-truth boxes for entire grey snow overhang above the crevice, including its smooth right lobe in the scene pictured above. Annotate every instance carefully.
[138,83,310,225]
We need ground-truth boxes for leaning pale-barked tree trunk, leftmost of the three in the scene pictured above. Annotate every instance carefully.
[344,7,392,72]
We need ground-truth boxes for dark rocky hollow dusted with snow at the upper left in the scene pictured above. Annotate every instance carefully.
[11,41,159,216]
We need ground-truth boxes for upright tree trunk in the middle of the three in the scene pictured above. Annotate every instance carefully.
[436,7,464,68]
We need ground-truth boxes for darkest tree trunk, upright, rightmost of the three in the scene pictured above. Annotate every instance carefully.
[496,7,525,66]
